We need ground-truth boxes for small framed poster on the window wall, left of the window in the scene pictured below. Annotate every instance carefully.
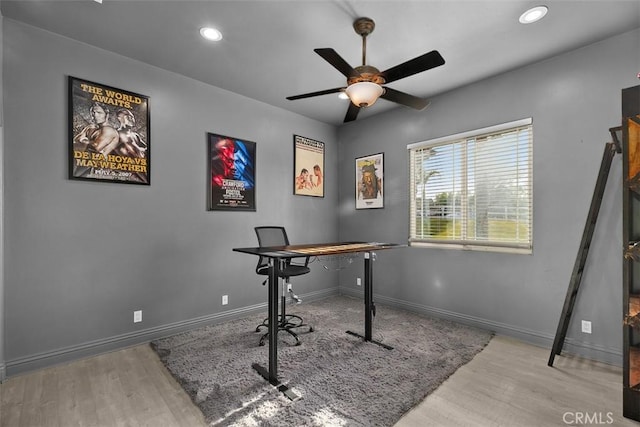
[356,153,384,209]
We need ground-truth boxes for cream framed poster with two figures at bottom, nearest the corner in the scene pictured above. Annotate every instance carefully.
[293,135,324,197]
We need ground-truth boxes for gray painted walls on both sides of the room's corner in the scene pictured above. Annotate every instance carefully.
[0,16,640,377]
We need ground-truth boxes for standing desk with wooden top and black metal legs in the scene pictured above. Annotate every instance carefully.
[233,242,400,400]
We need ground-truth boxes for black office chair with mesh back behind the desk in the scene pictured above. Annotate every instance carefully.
[255,226,313,345]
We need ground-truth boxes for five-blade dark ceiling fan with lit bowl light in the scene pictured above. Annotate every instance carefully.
[287,18,444,123]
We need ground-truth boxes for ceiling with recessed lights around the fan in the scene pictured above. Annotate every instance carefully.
[0,0,640,125]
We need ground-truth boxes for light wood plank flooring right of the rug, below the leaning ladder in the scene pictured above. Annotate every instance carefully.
[395,337,640,427]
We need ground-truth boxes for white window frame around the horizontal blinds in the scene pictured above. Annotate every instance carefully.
[407,118,533,254]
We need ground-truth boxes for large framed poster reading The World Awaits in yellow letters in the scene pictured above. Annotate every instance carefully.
[69,76,151,185]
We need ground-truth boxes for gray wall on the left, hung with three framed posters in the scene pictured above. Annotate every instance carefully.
[0,19,338,375]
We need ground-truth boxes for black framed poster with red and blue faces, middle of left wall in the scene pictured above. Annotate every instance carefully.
[207,133,256,212]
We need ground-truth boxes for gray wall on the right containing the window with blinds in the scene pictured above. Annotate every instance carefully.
[338,30,640,364]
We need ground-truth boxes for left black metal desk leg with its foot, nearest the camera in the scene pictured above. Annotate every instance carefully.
[251,258,300,400]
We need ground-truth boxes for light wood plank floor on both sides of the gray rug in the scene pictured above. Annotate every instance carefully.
[0,337,640,427]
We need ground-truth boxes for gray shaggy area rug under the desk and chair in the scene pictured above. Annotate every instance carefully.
[151,296,492,427]
